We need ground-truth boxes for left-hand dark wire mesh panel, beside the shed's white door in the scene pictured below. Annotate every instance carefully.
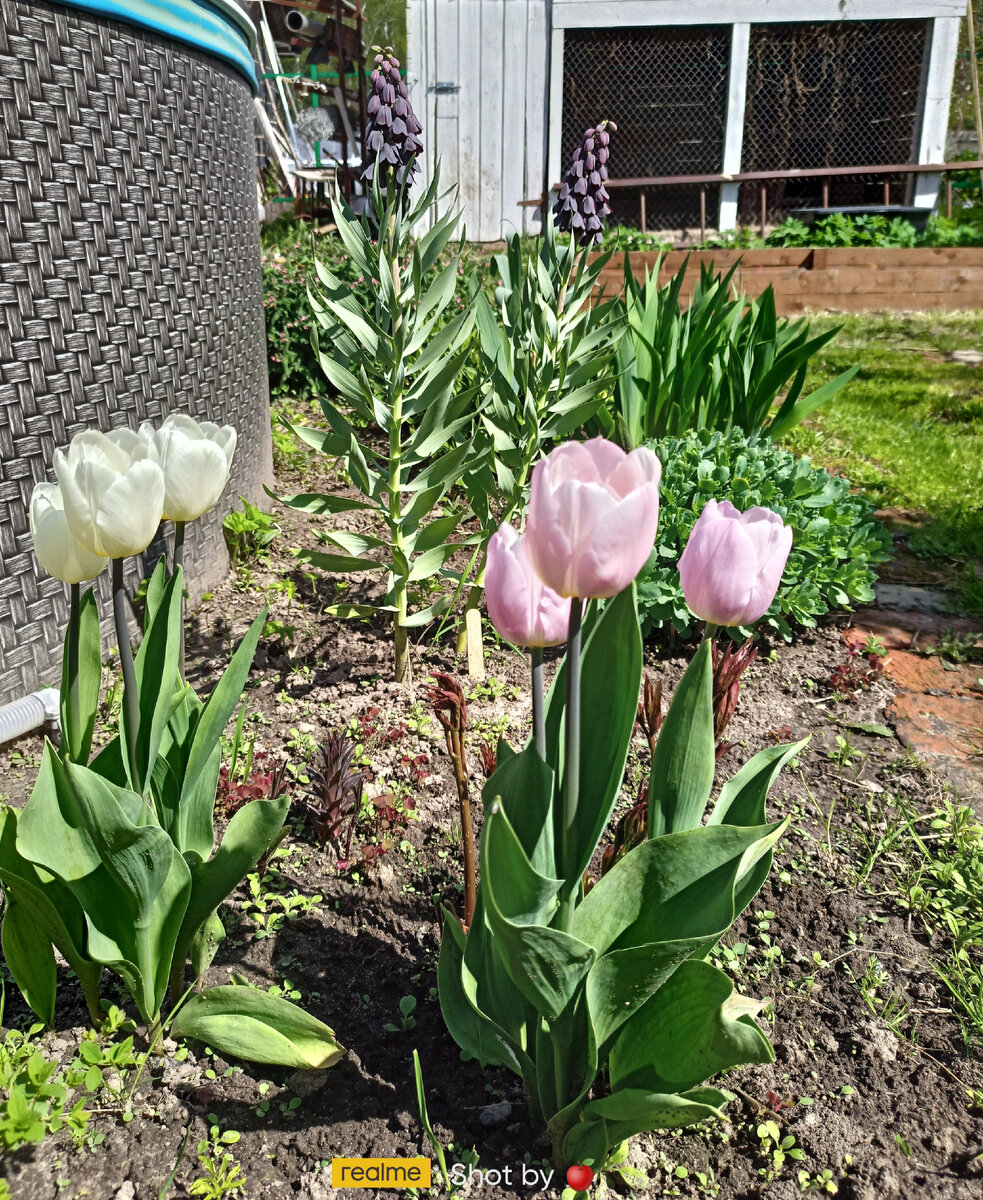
[562,25,731,229]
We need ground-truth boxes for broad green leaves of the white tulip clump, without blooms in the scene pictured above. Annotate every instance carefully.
[0,422,342,1067]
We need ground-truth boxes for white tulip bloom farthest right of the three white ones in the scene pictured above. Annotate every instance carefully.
[140,413,236,521]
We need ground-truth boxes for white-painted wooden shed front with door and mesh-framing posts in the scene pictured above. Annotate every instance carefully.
[407,0,965,241]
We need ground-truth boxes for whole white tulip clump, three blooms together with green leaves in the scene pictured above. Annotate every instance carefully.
[0,418,342,1067]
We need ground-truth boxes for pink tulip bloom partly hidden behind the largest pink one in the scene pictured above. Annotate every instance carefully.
[485,524,570,646]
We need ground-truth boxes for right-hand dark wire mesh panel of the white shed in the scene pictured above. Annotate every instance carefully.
[741,20,928,221]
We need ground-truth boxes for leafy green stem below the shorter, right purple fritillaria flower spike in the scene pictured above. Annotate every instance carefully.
[463,224,625,652]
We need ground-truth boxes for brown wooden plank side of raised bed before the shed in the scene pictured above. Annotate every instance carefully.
[600,246,983,314]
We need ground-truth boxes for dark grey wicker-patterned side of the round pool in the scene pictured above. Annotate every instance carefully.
[0,0,272,703]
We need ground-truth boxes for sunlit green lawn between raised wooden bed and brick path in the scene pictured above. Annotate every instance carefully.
[785,311,983,563]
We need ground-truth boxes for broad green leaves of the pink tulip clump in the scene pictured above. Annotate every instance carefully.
[439,584,805,1172]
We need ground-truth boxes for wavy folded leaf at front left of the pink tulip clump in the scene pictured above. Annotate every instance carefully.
[480,804,594,1020]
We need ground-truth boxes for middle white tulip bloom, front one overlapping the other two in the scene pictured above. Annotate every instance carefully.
[54,430,164,558]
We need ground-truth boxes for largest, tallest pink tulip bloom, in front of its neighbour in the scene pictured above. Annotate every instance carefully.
[526,438,663,599]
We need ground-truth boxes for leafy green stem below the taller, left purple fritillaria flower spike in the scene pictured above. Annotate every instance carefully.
[282,178,475,680]
